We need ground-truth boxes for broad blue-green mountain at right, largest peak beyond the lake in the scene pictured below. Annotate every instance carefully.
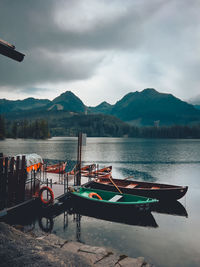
[108,89,200,125]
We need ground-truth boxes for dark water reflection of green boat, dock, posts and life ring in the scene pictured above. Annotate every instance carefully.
[2,201,158,233]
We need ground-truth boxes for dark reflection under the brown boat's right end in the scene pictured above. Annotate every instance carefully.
[151,200,188,218]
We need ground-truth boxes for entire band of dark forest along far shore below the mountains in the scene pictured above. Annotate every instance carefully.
[0,115,200,139]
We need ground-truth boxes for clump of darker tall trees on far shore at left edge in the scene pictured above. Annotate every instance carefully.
[0,115,50,139]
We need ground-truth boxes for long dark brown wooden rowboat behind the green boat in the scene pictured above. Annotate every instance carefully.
[84,178,188,201]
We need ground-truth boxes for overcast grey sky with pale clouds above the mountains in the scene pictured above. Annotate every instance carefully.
[0,0,200,106]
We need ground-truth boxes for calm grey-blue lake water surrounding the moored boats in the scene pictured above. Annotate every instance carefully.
[0,137,200,266]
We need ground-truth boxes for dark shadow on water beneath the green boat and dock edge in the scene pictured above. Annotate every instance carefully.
[4,193,158,230]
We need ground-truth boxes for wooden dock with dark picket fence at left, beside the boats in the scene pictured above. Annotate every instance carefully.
[0,154,91,219]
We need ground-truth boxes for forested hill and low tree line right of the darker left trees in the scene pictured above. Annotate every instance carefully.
[49,114,200,138]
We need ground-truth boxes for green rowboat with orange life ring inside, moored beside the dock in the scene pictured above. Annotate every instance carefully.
[70,187,157,210]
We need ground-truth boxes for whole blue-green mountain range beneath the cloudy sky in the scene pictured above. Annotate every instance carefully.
[0,88,200,126]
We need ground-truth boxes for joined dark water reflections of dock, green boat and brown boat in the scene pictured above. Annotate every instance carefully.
[2,200,188,237]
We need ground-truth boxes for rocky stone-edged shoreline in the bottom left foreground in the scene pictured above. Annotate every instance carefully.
[0,222,152,267]
